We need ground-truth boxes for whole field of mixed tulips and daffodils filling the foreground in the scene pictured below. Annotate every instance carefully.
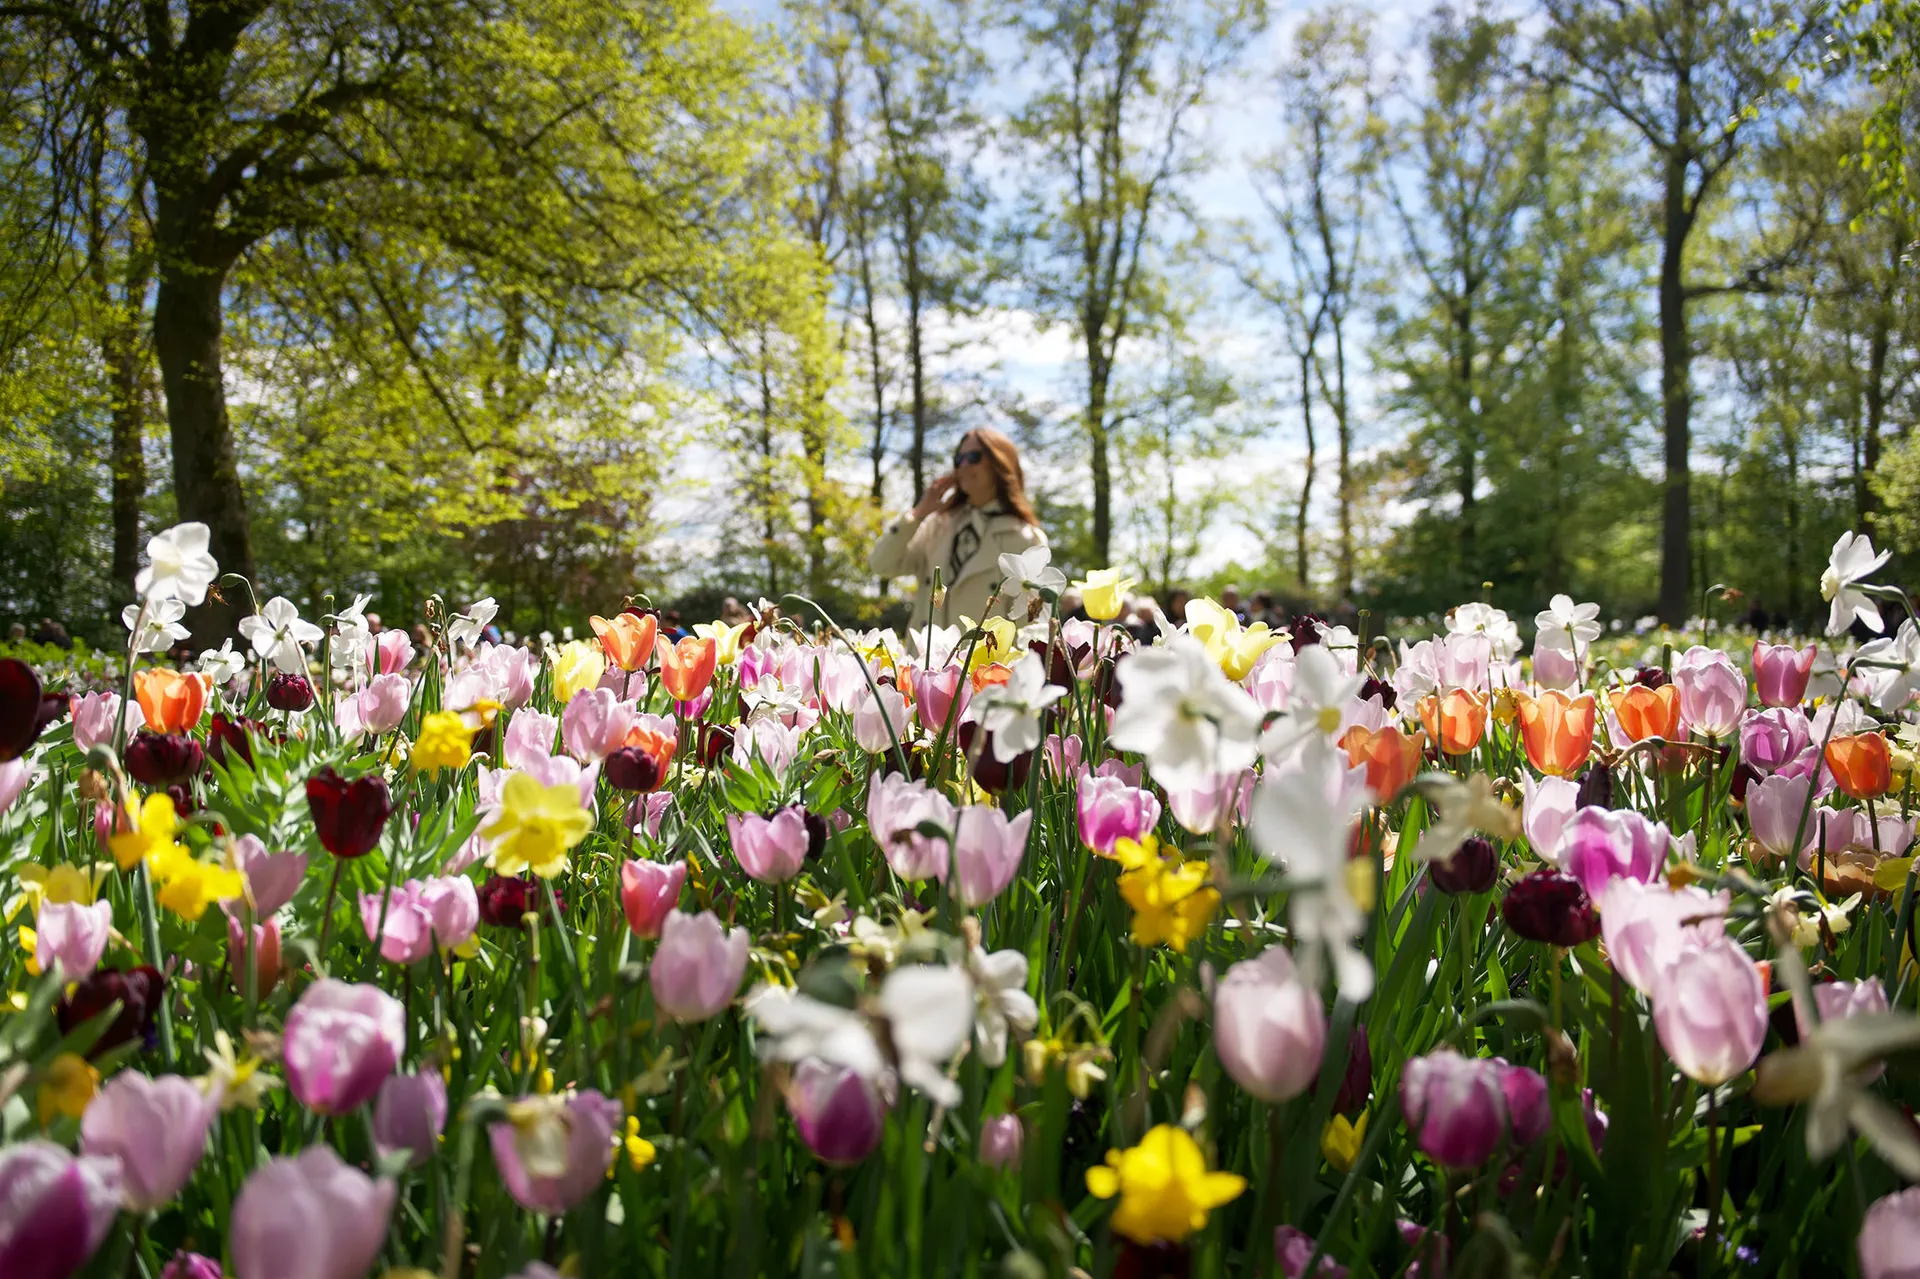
[0,524,1920,1279]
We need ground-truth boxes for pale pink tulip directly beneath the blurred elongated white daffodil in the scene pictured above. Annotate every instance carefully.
[1213,945,1327,1102]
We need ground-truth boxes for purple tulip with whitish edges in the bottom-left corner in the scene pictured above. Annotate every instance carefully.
[0,1139,123,1279]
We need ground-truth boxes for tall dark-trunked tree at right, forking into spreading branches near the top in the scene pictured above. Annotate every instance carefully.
[1546,0,1812,624]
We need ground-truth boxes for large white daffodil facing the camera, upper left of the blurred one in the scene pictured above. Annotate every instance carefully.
[1108,634,1260,785]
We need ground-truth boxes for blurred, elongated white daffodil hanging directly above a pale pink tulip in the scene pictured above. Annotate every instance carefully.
[1248,739,1373,1002]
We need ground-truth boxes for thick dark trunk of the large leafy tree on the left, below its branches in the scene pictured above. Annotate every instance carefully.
[154,257,255,643]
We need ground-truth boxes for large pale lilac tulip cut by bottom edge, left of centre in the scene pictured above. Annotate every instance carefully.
[227,1145,396,1279]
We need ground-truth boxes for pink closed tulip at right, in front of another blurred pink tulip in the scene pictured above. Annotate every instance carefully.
[1653,935,1766,1087]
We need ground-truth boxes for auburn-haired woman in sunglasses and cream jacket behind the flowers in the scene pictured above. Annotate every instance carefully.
[866,426,1046,626]
